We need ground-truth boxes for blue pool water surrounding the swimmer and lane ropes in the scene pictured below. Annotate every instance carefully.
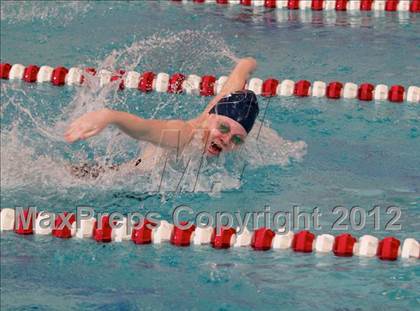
[0,1,420,310]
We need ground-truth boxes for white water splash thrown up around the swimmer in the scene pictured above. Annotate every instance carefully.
[1,30,306,206]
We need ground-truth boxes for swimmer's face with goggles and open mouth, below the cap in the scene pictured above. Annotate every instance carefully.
[205,114,247,156]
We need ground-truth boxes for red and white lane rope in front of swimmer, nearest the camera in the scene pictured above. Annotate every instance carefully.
[0,208,420,261]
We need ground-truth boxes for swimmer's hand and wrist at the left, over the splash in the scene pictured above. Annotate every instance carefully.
[64,109,112,143]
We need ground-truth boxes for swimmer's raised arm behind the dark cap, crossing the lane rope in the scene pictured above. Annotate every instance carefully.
[203,57,257,115]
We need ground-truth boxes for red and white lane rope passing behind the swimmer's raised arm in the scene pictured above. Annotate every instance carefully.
[0,63,420,103]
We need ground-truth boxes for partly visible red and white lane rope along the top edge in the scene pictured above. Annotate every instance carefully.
[172,0,420,13]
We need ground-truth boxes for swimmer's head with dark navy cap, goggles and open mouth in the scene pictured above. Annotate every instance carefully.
[205,91,259,156]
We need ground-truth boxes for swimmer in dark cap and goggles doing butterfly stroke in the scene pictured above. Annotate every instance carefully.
[64,57,259,178]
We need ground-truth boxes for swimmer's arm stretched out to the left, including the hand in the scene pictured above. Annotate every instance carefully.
[65,109,193,148]
